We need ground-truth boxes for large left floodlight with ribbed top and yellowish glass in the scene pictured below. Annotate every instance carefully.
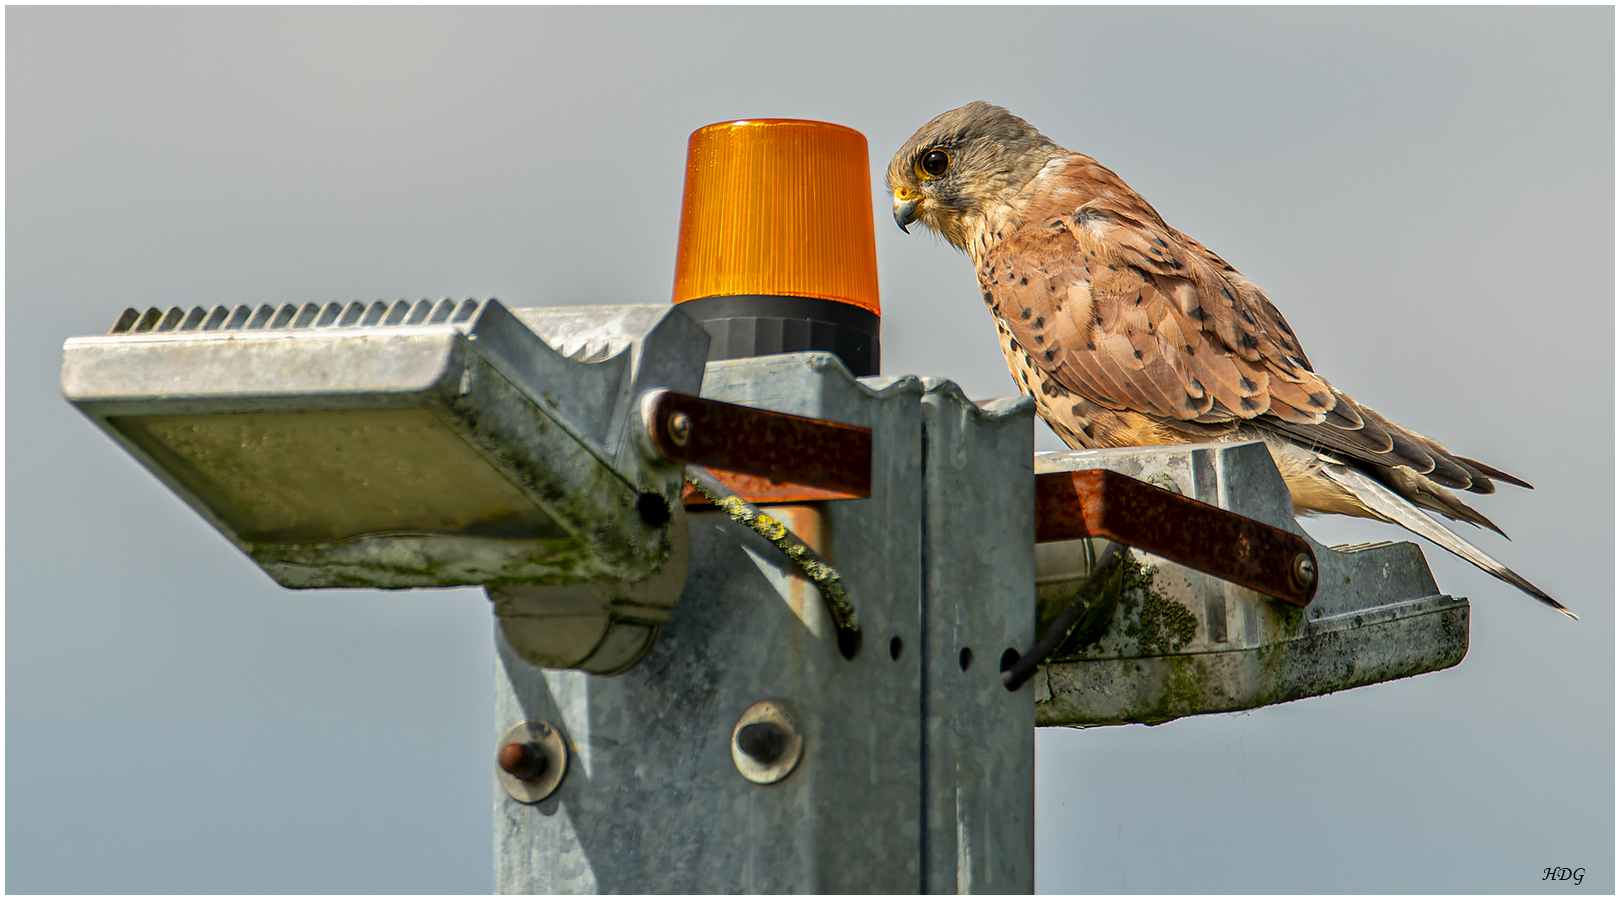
[62,299,708,598]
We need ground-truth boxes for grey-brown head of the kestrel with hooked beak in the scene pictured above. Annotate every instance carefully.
[888,100,1066,249]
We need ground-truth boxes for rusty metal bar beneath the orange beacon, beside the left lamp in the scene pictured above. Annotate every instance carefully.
[646,390,872,502]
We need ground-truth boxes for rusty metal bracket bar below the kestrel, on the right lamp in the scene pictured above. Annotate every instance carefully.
[1035,469,1317,607]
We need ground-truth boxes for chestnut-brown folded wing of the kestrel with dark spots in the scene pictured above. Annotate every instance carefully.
[980,154,1518,492]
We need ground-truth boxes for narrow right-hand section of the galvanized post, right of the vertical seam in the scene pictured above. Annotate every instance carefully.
[922,379,1035,894]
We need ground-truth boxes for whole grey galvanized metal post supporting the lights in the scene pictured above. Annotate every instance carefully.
[496,353,1035,894]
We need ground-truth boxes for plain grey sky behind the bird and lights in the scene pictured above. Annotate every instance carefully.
[5,6,1615,894]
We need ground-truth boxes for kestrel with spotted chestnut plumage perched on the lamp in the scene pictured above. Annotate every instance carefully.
[888,102,1575,618]
